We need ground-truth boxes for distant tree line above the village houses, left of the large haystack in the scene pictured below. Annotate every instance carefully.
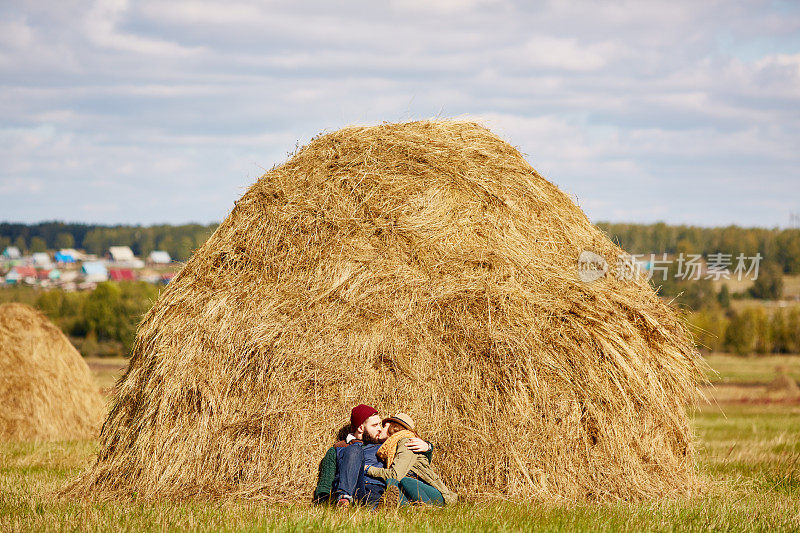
[0,222,217,261]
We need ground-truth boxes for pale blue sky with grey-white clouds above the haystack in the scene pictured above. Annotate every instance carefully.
[0,0,800,227]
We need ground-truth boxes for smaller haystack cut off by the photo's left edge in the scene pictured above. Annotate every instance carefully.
[0,304,103,440]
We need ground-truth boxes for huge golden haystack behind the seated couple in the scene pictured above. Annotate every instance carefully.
[73,122,697,500]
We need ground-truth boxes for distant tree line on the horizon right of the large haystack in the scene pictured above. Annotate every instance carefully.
[597,222,800,274]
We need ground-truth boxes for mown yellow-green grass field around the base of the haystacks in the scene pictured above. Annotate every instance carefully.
[0,355,800,532]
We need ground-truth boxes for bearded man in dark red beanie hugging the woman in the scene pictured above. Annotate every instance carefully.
[314,404,432,506]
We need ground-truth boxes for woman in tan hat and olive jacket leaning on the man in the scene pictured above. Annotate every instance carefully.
[365,413,458,505]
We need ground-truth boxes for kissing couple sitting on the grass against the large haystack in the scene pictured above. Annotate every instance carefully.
[314,404,457,507]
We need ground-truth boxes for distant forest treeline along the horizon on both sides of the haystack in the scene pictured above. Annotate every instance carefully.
[0,222,800,274]
